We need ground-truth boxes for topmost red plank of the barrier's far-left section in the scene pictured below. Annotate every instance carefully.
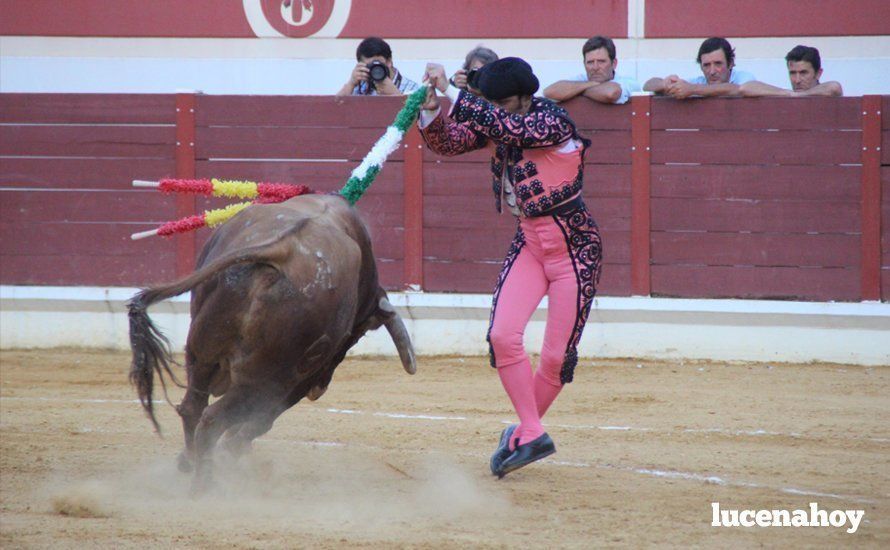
[0,93,175,126]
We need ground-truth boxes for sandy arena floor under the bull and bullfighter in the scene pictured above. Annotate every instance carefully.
[0,350,890,548]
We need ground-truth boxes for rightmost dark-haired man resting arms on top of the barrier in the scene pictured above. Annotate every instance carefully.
[741,46,844,97]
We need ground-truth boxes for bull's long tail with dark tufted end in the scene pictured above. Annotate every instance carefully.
[127,239,289,434]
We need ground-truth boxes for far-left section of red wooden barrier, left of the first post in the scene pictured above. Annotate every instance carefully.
[0,93,176,286]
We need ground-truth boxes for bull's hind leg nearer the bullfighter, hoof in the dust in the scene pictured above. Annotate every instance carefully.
[191,386,282,496]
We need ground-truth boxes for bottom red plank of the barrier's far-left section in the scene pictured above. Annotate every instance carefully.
[0,256,175,286]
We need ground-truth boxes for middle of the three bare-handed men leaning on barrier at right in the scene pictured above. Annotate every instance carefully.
[643,37,754,99]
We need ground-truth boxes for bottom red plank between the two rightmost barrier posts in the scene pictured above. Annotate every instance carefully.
[652,265,859,302]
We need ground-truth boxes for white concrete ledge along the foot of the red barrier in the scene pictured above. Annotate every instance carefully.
[0,286,890,365]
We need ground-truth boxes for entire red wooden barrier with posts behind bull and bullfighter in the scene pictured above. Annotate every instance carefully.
[0,94,890,301]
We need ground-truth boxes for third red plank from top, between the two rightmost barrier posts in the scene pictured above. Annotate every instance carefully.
[652,164,862,201]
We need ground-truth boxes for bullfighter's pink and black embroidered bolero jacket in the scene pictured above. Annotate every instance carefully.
[421,91,590,217]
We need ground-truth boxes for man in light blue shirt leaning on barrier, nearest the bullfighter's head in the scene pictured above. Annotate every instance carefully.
[544,36,640,104]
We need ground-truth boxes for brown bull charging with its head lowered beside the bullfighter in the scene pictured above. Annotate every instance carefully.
[129,195,415,492]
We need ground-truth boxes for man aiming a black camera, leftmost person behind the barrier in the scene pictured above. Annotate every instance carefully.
[337,36,419,97]
